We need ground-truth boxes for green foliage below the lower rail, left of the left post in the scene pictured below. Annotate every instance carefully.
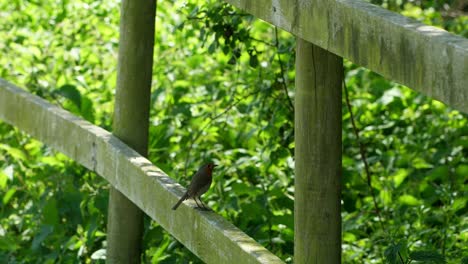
[0,127,107,263]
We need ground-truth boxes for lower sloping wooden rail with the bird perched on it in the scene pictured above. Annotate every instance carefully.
[0,79,283,263]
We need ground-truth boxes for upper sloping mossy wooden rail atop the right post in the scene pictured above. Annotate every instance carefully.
[225,0,468,113]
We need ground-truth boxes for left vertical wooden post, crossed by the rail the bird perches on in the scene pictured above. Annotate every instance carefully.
[107,0,156,263]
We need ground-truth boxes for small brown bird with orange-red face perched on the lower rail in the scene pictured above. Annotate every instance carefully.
[172,162,216,210]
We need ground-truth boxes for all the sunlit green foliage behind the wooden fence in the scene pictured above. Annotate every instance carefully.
[0,0,468,263]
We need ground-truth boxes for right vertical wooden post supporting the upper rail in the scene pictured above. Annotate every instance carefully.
[294,38,343,264]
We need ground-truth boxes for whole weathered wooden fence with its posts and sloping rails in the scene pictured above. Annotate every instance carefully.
[0,0,468,263]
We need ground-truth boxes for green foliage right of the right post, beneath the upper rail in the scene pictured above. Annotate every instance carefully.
[343,65,468,263]
